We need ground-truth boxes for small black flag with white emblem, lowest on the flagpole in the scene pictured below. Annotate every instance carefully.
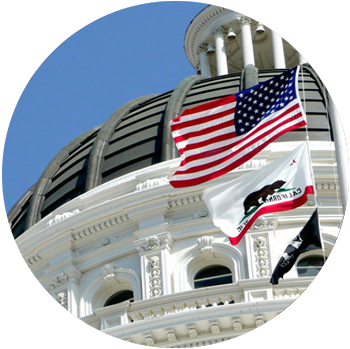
[270,208,322,285]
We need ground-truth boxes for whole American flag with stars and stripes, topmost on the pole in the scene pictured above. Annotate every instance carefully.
[170,67,306,188]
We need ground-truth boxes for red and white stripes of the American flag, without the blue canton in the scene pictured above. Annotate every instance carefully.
[170,95,306,188]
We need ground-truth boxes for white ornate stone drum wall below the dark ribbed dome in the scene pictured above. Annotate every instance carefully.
[16,142,343,348]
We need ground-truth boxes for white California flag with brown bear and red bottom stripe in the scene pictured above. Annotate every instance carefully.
[203,141,314,245]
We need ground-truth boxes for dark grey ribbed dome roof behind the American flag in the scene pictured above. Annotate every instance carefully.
[8,66,331,237]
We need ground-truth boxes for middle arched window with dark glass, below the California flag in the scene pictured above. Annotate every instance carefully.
[194,265,232,288]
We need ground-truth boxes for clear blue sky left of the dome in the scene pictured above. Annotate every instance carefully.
[3,1,208,212]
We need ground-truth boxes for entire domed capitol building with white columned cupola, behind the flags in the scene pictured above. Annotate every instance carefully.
[9,6,348,348]
